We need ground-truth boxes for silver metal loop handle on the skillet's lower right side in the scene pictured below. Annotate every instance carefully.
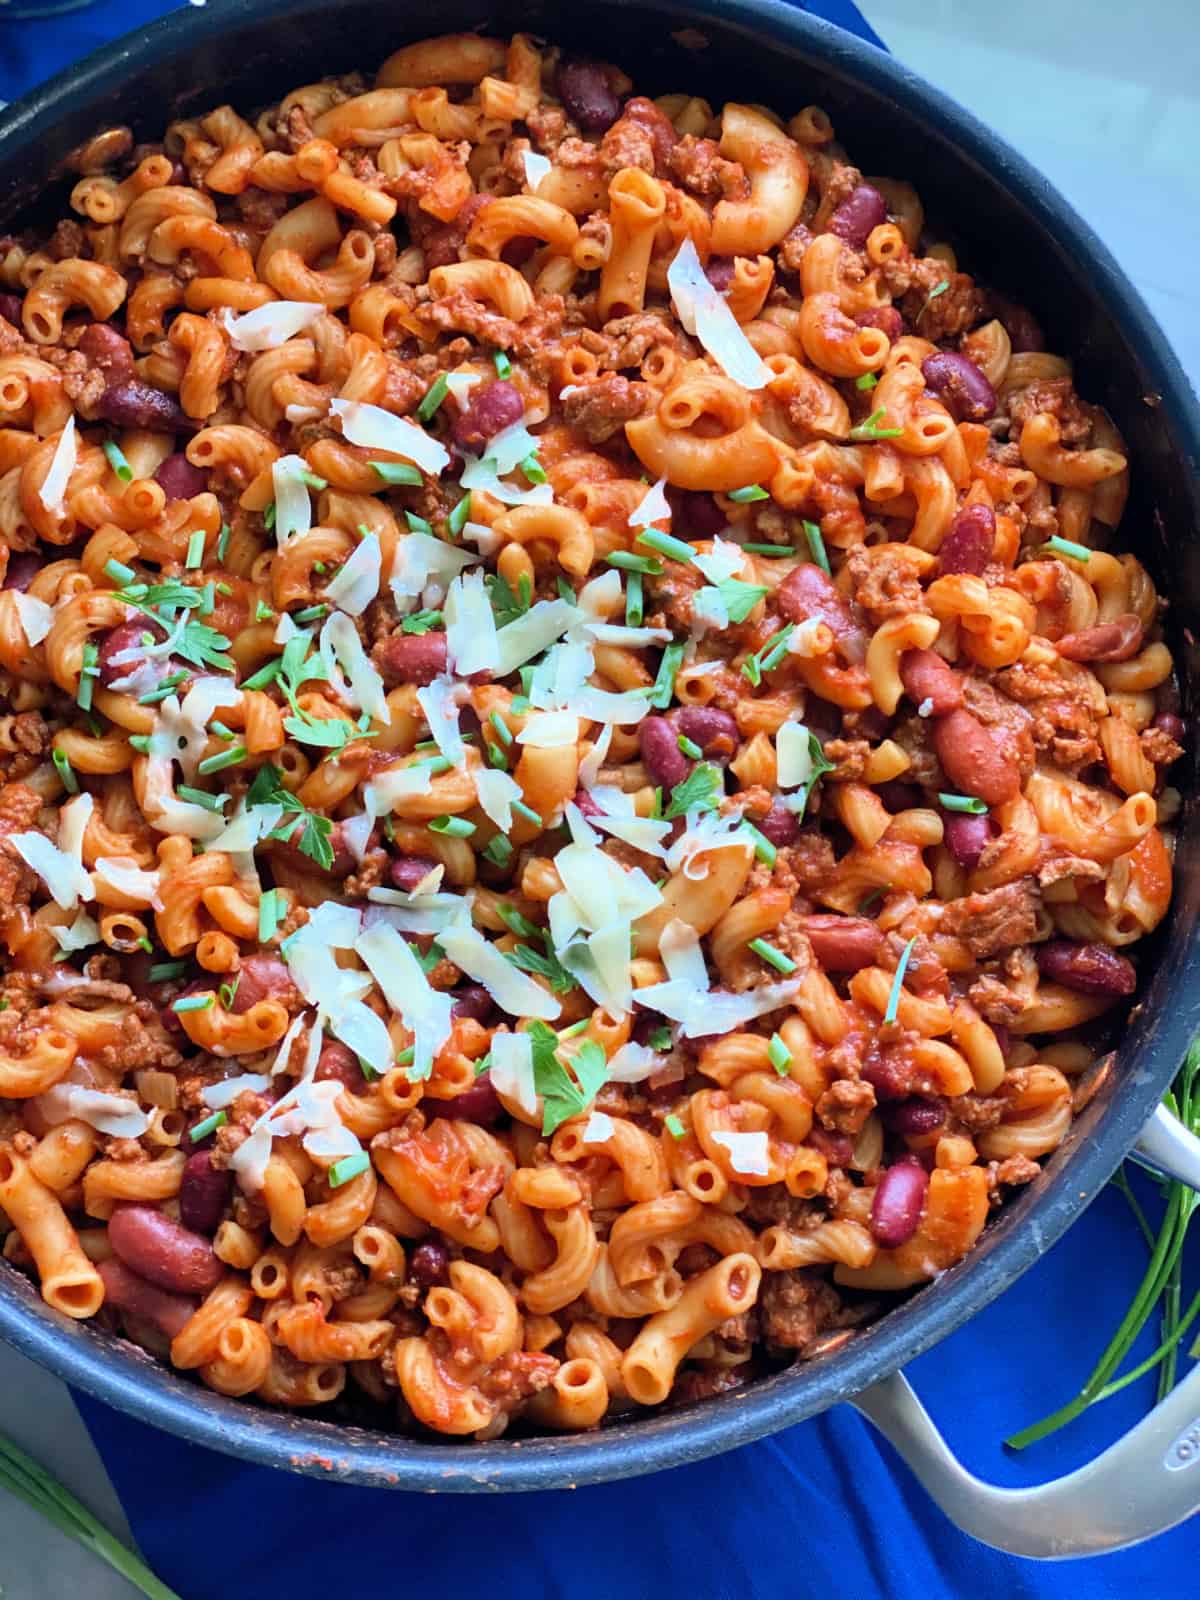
[850,1107,1200,1562]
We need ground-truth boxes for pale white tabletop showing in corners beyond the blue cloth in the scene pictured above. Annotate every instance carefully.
[0,0,1200,1600]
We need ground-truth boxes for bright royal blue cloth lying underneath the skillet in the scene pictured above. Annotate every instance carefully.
[0,0,1200,1600]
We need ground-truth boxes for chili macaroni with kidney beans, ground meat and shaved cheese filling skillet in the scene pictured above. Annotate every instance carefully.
[0,35,1184,1438]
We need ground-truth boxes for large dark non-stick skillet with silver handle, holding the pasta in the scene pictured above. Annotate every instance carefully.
[0,0,1200,1557]
